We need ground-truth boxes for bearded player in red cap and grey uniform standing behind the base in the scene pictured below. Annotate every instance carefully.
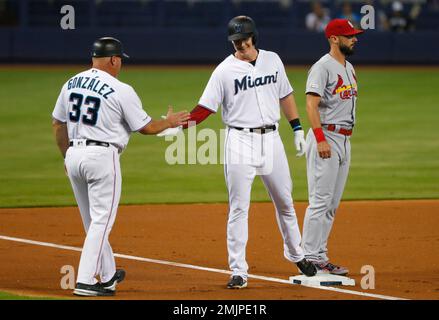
[302,19,363,275]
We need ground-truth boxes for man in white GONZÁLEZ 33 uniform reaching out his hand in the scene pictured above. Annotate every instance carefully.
[52,37,189,296]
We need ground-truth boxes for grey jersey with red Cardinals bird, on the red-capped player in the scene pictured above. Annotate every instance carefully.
[306,54,358,127]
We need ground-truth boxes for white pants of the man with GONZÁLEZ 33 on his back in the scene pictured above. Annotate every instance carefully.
[65,146,122,284]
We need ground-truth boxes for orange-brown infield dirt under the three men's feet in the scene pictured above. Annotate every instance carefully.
[0,200,439,300]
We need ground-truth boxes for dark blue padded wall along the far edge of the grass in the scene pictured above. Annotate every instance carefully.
[0,27,439,64]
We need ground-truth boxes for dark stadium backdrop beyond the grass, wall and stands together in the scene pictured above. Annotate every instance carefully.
[0,0,439,64]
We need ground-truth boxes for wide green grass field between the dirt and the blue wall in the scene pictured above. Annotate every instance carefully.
[0,67,439,207]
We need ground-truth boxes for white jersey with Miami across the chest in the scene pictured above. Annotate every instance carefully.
[199,50,293,128]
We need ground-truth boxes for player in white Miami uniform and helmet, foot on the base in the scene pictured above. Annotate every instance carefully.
[160,16,316,289]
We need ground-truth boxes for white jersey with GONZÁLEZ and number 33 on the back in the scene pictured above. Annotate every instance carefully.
[52,68,152,150]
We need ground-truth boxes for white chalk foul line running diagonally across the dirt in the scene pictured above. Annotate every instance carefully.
[0,235,408,300]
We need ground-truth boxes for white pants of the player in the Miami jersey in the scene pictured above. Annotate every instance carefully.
[224,128,304,279]
